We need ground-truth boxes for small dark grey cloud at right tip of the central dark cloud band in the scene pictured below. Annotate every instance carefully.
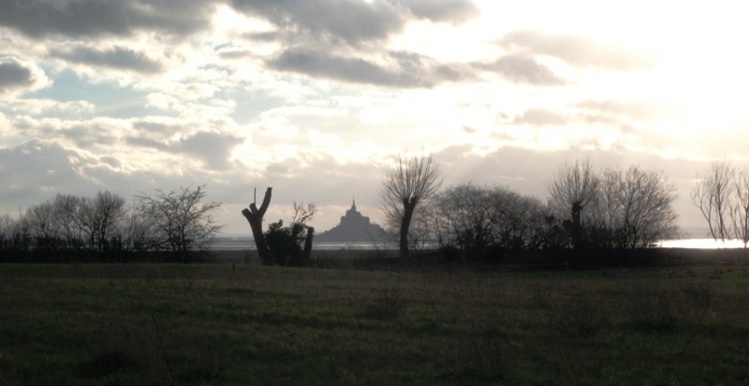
[474,54,565,86]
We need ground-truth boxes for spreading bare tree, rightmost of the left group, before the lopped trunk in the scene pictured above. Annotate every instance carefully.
[136,186,221,261]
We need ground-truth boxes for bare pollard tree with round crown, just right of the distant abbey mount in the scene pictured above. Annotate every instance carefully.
[380,156,442,256]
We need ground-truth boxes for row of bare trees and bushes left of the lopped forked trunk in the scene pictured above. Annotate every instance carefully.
[0,186,221,262]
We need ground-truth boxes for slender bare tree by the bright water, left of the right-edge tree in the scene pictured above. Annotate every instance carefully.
[692,161,736,241]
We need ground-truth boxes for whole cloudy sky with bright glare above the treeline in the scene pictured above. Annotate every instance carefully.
[0,0,749,235]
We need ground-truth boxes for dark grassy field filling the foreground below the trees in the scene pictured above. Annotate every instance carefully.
[0,264,749,385]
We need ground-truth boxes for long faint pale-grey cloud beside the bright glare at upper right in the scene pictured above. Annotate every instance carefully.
[499,31,652,71]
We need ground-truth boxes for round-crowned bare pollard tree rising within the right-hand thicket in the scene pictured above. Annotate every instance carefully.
[549,160,600,249]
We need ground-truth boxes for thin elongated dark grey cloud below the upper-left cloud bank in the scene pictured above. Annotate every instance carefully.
[52,46,163,74]
